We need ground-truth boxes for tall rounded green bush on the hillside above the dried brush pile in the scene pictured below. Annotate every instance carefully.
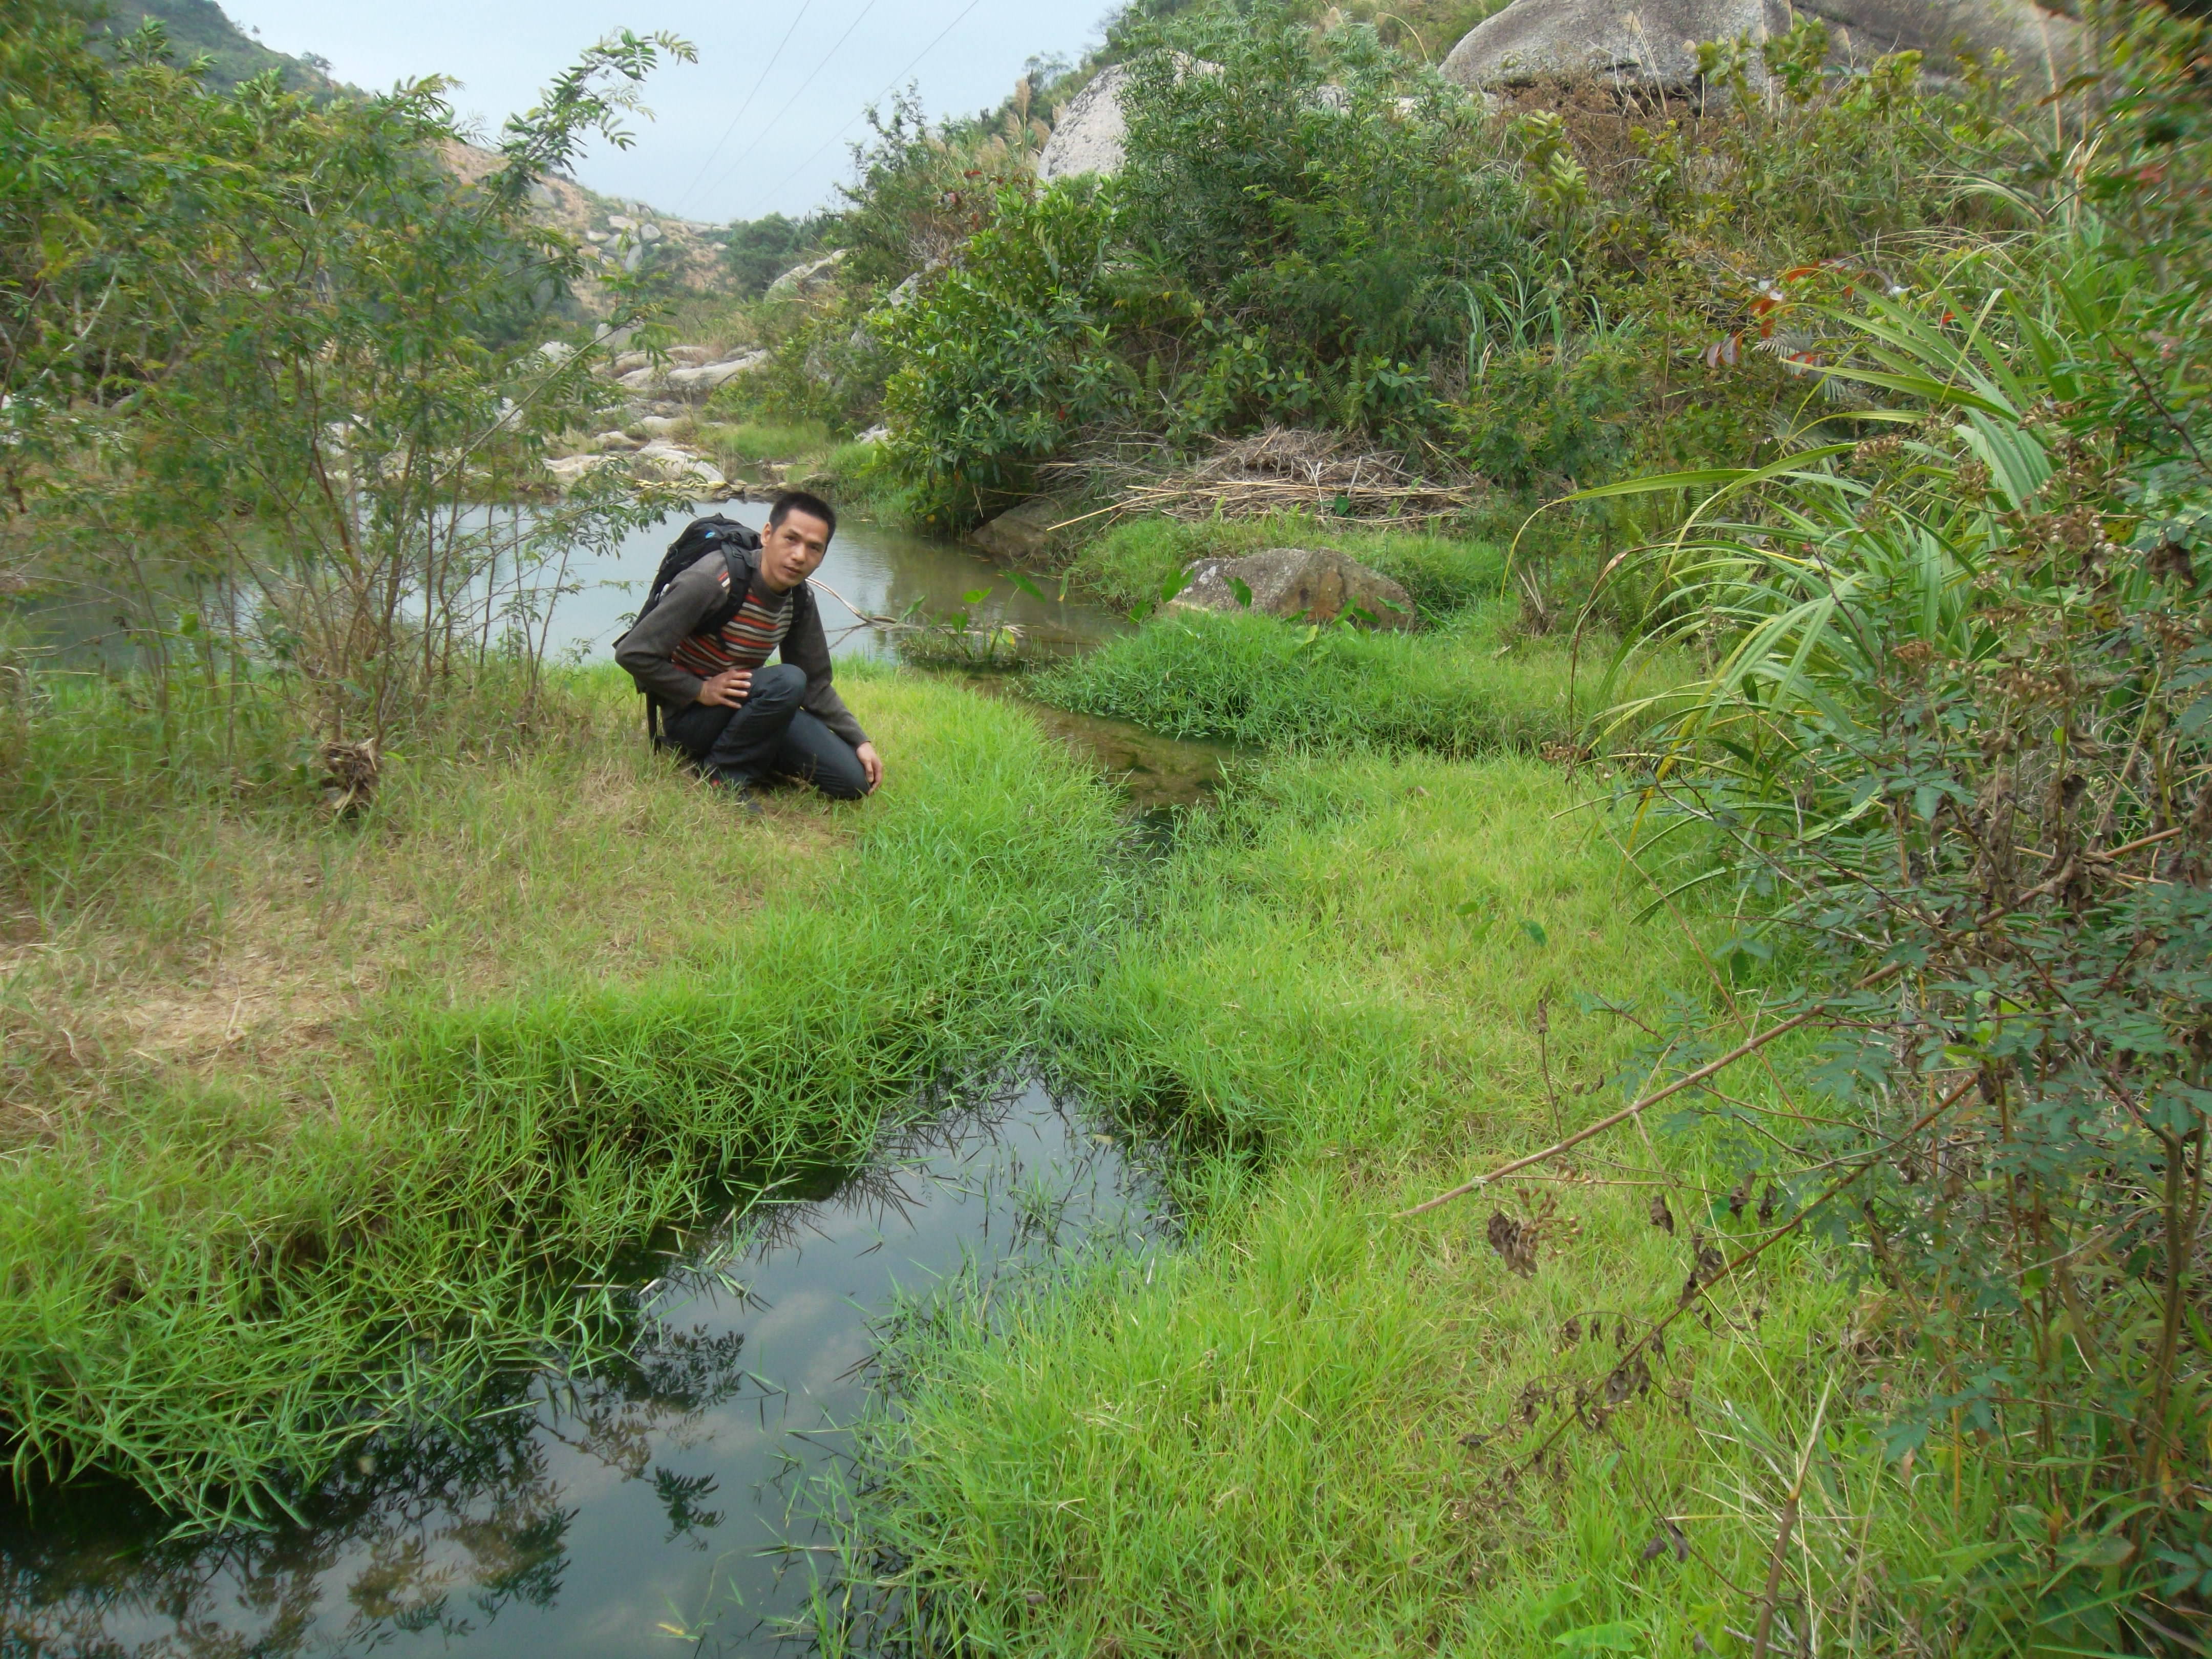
[1119,5,1528,442]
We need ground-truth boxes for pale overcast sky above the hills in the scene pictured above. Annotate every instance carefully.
[221,0,1111,223]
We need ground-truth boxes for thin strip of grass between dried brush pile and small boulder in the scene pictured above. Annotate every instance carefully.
[1069,513,1504,615]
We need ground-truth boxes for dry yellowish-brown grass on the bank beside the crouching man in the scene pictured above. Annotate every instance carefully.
[0,681,852,1146]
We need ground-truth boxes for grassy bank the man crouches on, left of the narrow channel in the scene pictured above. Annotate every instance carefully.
[0,659,1117,1518]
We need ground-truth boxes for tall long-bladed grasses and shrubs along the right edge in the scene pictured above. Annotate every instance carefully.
[1575,18,2212,1650]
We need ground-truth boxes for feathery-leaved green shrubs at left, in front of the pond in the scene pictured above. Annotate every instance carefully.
[0,7,690,741]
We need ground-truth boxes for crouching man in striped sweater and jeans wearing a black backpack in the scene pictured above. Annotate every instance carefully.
[615,491,883,810]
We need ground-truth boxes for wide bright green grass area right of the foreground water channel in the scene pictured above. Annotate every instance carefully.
[858,756,1989,1659]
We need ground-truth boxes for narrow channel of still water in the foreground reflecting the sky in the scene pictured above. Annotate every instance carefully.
[0,1086,1159,1659]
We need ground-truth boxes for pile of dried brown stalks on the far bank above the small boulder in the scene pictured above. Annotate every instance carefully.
[1117,427,1480,524]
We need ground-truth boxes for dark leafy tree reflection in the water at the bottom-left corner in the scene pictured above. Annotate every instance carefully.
[0,1321,748,1659]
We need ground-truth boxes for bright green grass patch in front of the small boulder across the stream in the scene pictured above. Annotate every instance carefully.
[1035,608,1602,754]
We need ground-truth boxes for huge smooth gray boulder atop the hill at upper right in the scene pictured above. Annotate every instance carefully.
[1442,0,2079,91]
